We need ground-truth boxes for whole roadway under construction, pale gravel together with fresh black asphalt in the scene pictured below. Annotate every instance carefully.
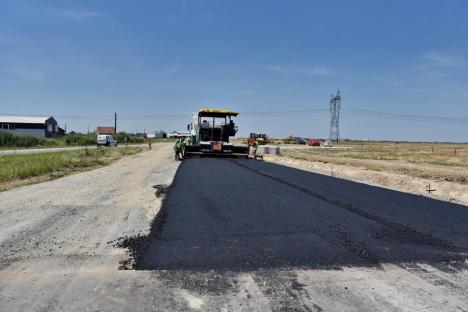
[0,145,468,311]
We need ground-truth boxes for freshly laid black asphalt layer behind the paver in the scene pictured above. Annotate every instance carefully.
[121,158,468,272]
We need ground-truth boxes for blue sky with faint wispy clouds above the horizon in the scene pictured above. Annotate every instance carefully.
[0,0,468,141]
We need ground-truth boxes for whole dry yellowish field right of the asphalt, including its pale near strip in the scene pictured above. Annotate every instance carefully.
[282,142,468,184]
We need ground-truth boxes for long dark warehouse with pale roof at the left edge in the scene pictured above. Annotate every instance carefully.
[0,116,59,138]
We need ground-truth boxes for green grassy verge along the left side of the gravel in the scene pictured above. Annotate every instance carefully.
[0,147,141,191]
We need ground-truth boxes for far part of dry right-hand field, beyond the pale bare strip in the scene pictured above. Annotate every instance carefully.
[282,142,468,167]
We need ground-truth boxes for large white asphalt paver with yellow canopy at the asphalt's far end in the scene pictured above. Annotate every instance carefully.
[185,108,249,158]
